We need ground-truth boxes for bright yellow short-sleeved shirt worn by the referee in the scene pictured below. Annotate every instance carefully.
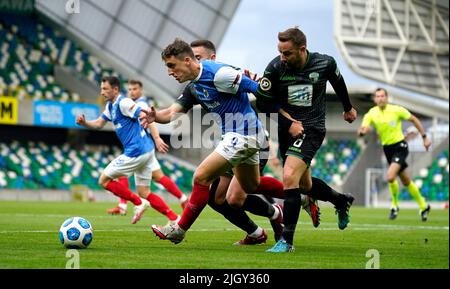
[362,104,411,145]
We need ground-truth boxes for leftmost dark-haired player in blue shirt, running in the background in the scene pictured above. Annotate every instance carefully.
[76,76,178,224]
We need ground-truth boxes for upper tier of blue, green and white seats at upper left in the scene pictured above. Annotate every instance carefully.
[0,14,137,102]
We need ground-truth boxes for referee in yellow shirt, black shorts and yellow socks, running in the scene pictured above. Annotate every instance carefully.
[359,88,431,222]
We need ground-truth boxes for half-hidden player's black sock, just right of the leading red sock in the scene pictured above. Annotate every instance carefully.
[208,181,258,235]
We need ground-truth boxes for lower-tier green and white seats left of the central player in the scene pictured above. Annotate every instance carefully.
[0,140,193,192]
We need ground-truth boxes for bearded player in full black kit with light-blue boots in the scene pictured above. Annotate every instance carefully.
[256,27,357,253]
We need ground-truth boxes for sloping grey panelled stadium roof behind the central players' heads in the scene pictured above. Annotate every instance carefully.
[35,0,240,104]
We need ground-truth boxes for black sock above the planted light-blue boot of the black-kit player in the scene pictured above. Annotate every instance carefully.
[283,188,302,245]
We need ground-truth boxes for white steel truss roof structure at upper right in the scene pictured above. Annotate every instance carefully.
[335,0,449,103]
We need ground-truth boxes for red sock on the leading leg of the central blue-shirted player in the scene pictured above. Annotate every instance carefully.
[178,183,209,231]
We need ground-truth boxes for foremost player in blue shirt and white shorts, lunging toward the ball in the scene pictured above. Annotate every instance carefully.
[148,39,282,243]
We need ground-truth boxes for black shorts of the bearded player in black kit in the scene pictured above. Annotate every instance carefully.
[278,128,326,167]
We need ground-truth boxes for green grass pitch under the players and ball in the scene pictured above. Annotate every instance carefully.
[0,201,449,269]
